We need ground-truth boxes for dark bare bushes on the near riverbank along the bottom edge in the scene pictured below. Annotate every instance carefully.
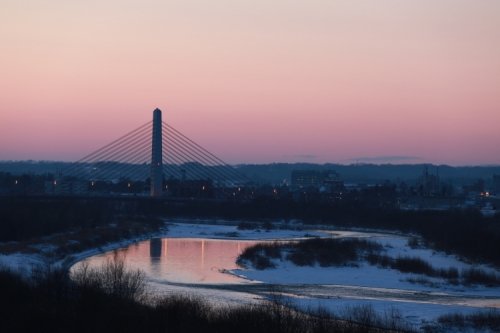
[0,262,408,333]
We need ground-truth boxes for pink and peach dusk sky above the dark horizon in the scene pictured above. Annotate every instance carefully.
[0,0,500,165]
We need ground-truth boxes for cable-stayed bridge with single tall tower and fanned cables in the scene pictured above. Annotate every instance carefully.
[52,109,249,197]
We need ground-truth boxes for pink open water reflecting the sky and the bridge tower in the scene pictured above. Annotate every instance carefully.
[78,238,256,283]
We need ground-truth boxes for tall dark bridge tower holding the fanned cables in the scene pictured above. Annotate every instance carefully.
[150,109,163,197]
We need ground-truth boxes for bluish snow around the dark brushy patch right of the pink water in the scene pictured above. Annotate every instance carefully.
[232,232,500,296]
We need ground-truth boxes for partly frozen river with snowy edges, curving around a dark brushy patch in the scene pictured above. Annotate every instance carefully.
[71,223,500,325]
